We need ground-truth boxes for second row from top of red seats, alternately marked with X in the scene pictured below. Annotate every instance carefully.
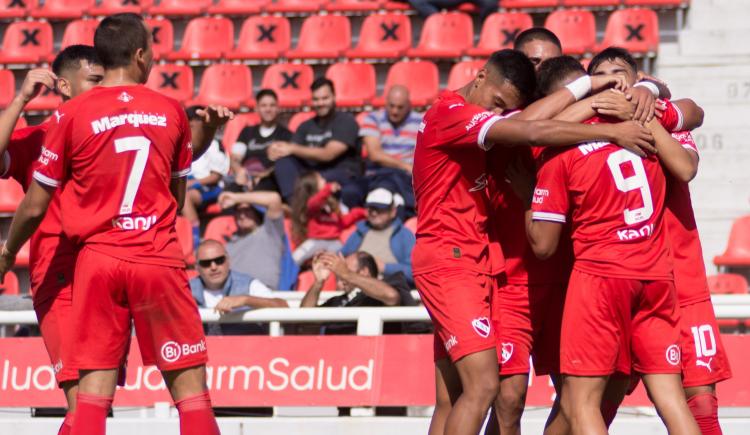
[0,8,659,64]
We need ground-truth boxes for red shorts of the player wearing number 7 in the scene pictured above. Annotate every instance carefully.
[71,247,207,371]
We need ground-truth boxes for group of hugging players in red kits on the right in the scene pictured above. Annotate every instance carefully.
[413,28,731,435]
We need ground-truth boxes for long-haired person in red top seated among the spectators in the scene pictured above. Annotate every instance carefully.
[292,171,366,265]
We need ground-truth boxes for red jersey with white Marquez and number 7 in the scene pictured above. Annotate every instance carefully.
[34,86,192,267]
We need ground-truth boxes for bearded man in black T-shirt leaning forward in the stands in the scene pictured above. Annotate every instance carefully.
[268,77,364,207]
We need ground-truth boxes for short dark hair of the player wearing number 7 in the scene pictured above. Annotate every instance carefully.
[94,13,151,69]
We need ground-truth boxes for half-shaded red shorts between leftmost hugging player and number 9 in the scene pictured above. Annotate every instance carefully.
[492,284,566,375]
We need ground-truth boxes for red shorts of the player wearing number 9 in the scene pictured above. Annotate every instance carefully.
[560,270,681,376]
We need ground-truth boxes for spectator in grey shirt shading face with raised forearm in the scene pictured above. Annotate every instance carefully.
[219,192,286,289]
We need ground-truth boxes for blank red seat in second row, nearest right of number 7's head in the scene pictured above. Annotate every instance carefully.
[167,17,234,60]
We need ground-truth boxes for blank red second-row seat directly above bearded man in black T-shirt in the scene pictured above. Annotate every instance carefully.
[287,15,352,59]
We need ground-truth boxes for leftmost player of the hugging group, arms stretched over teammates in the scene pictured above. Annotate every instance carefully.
[412,50,651,434]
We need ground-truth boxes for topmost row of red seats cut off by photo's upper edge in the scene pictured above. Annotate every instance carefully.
[0,0,689,20]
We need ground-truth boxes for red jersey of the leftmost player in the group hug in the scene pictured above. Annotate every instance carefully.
[412,91,504,274]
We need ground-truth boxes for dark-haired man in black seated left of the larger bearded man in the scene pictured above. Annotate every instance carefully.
[232,89,292,192]
